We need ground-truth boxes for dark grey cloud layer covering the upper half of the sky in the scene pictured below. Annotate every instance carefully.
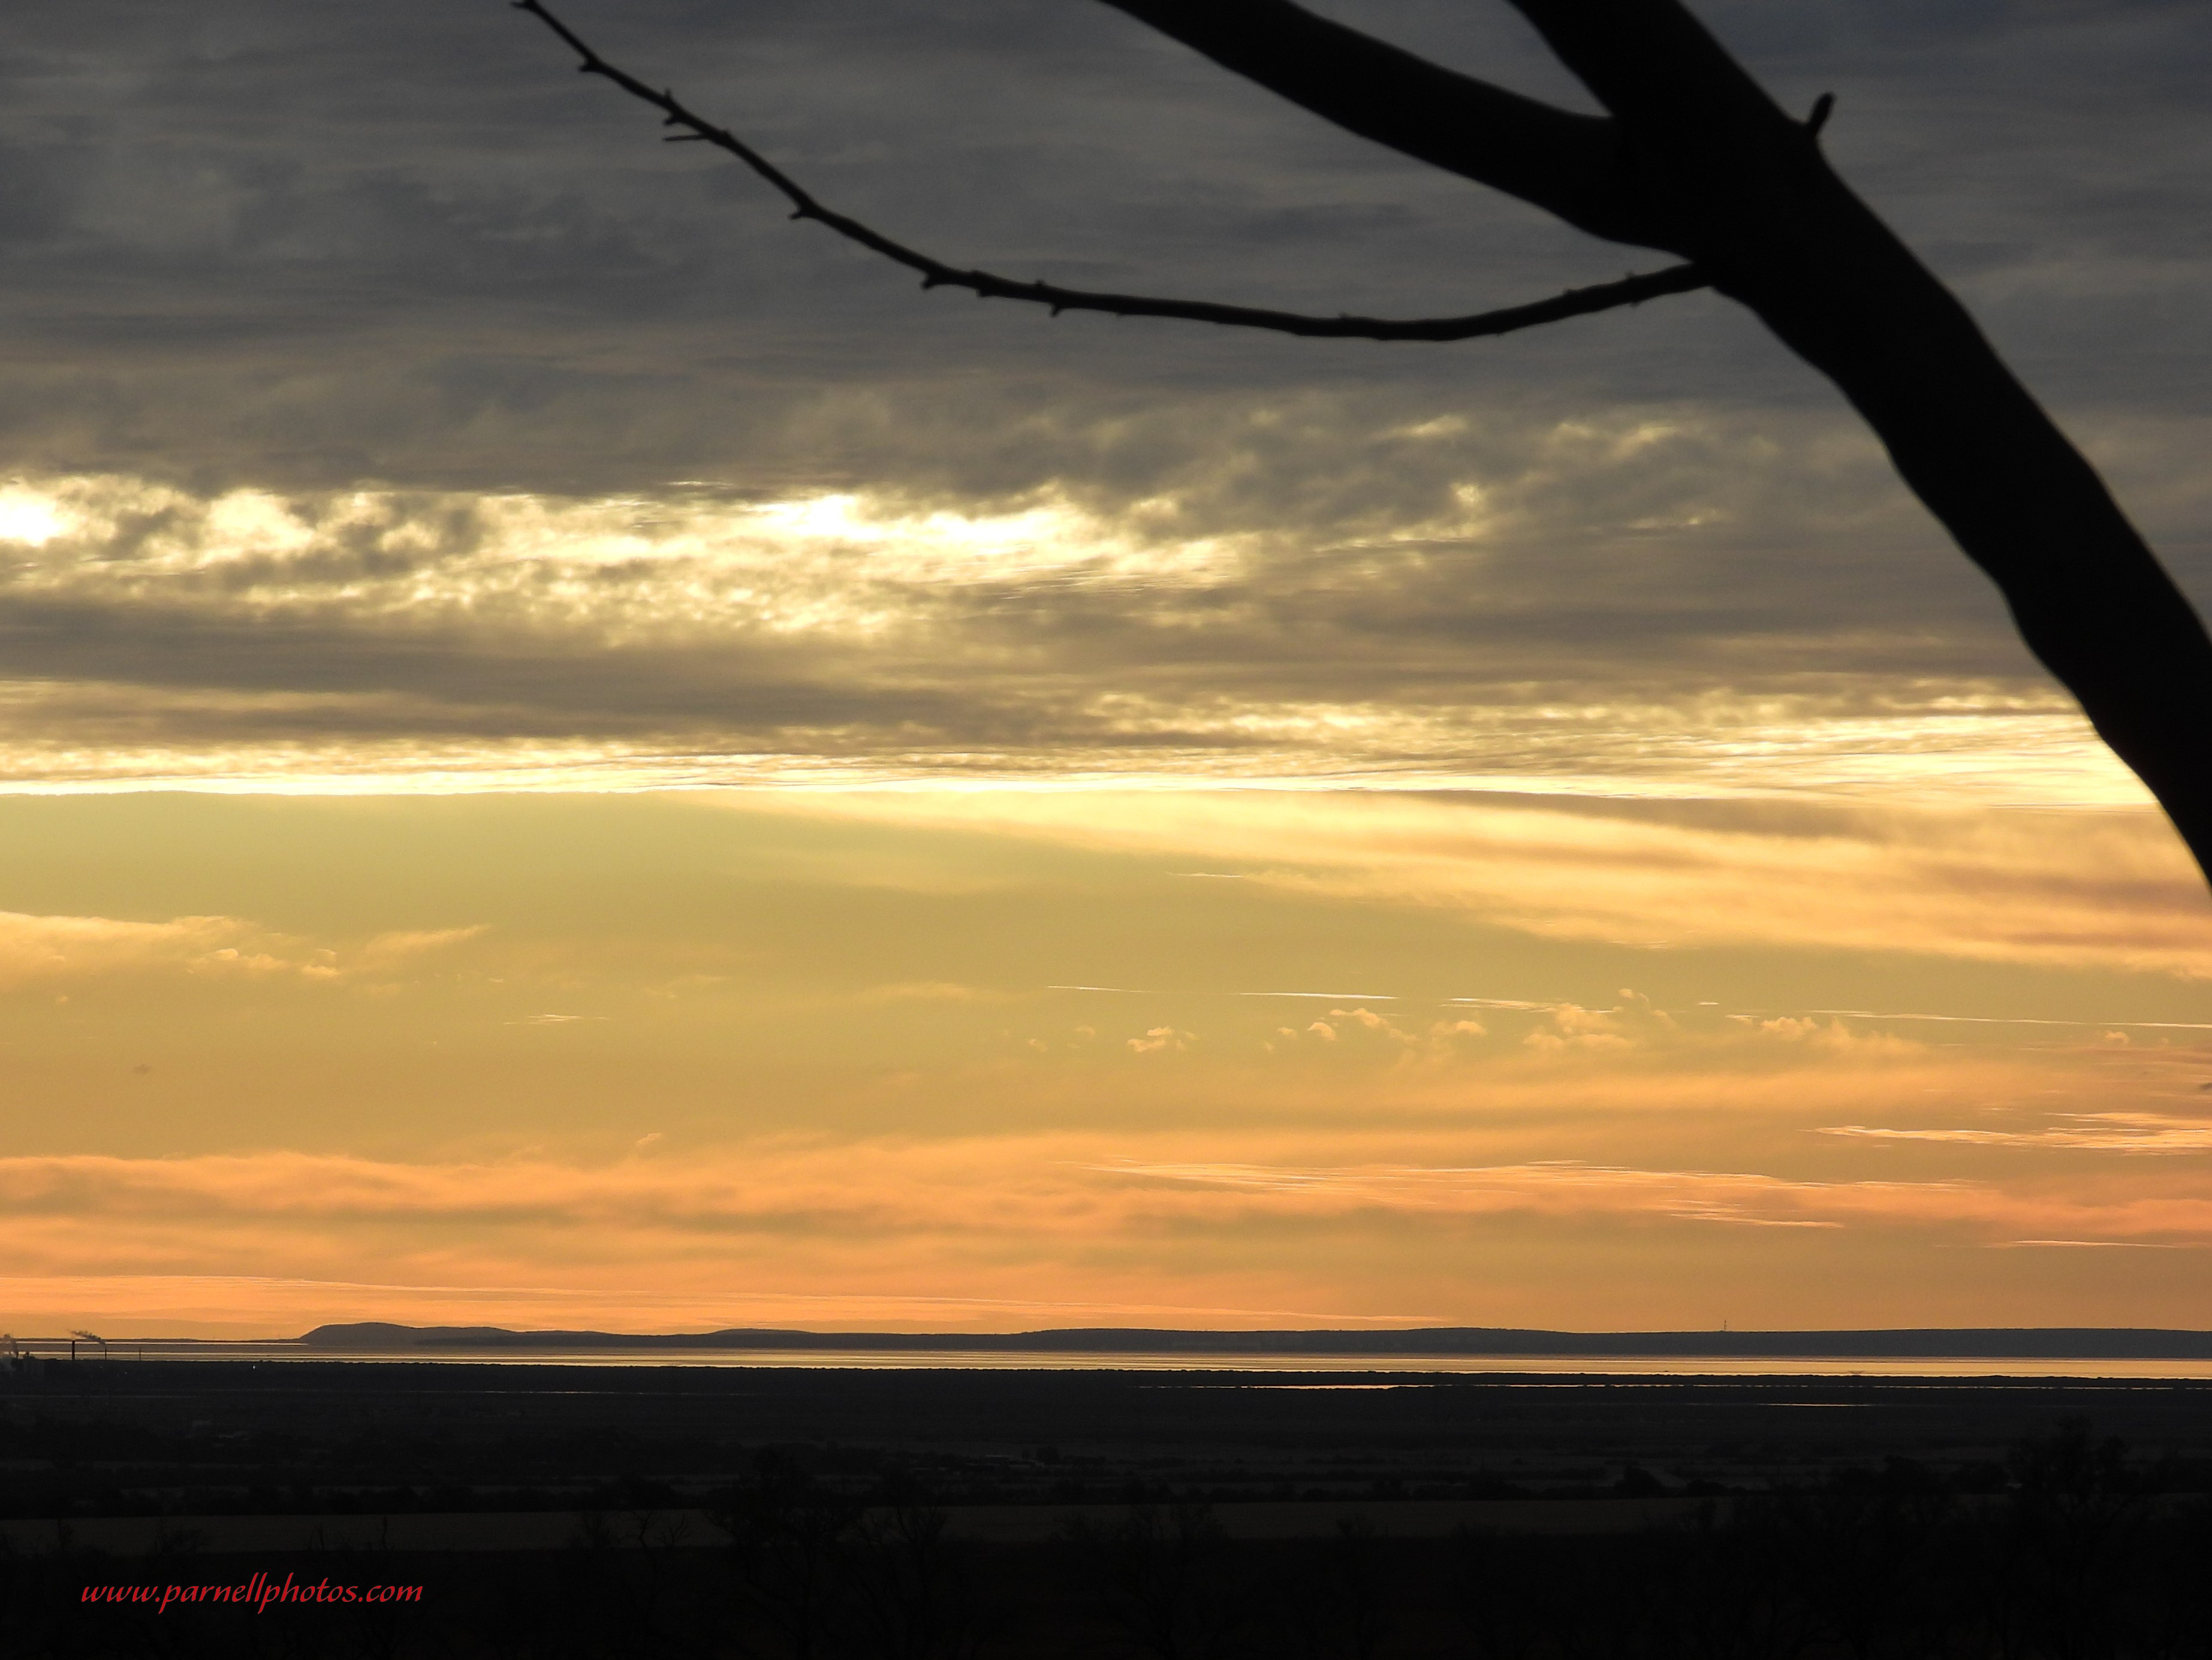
[0,0,2212,787]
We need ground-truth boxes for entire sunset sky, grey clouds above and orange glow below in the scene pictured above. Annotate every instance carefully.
[0,0,2212,1335]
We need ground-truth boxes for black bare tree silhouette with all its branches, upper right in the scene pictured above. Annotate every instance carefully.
[513,0,2212,897]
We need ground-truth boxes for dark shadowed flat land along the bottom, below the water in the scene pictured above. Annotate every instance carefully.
[0,1359,2212,1660]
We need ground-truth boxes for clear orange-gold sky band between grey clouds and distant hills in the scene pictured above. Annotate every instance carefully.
[0,791,2212,1335]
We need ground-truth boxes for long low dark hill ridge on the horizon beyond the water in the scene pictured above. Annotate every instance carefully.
[301,1320,2212,1359]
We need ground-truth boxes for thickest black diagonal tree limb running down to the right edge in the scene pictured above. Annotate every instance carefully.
[1513,0,2212,873]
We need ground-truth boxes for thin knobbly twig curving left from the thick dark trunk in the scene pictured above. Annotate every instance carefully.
[513,0,1710,340]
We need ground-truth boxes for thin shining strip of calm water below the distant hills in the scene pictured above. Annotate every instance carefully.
[22,1337,2212,1381]
